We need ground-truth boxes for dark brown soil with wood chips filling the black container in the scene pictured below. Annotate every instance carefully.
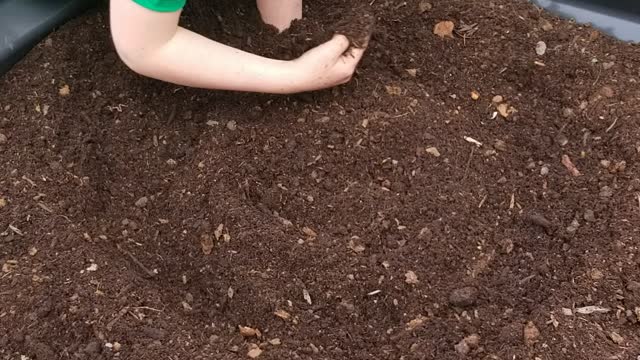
[0,0,640,360]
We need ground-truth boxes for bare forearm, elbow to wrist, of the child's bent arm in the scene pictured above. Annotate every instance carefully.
[122,28,299,93]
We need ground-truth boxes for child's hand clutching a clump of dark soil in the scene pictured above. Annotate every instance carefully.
[293,35,365,92]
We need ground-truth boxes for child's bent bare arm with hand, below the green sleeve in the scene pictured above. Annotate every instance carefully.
[111,0,364,93]
